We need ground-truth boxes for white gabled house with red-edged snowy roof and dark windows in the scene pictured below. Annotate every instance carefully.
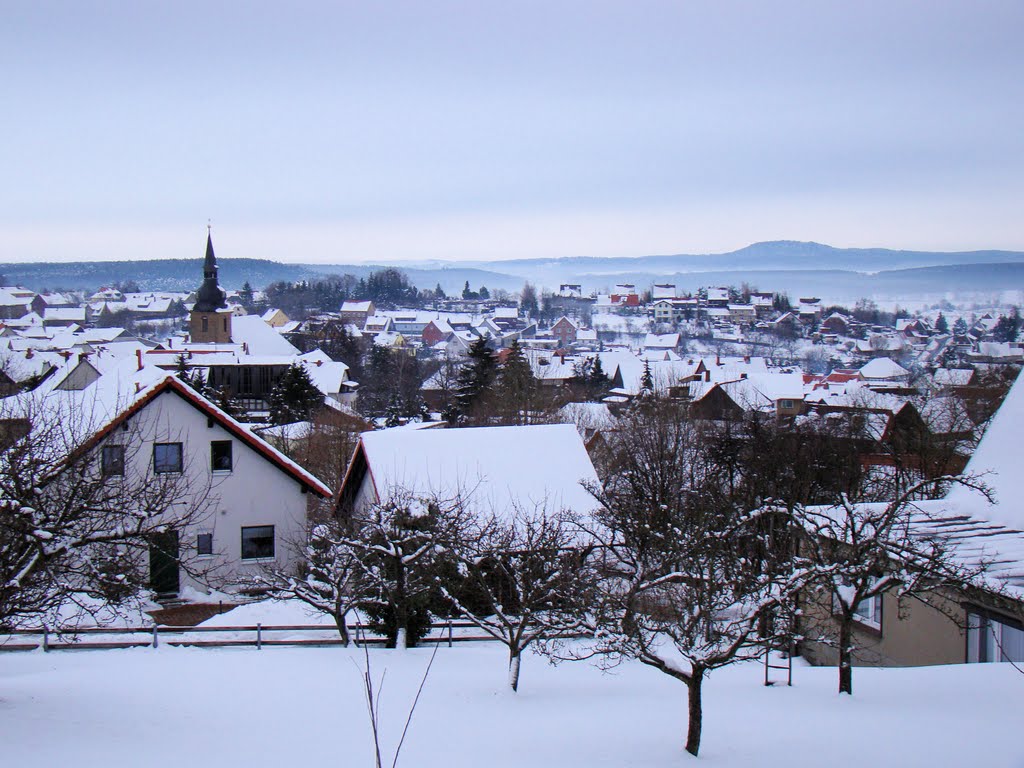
[5,360,331,594]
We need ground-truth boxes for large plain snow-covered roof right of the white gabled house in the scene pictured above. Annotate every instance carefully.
[354,424,598,515]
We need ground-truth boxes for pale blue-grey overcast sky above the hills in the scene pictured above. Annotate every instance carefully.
[0,0,1024,263]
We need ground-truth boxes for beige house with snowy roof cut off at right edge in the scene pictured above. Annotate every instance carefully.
[802,382,1024,667]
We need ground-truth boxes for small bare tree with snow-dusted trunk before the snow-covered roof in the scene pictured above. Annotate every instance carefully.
[441,506,590,690]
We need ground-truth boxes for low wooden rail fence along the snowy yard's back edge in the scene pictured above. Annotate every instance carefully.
[0,621,494,651]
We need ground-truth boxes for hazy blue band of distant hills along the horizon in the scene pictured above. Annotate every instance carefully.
[0,241,1024,300]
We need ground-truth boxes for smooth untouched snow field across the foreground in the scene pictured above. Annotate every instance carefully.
[0,643,1024,768]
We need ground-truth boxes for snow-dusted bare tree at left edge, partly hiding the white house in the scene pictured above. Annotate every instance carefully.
[0,400,210,625]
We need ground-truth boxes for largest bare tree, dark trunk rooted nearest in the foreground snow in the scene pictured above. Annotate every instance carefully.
[591,399,803,755]
